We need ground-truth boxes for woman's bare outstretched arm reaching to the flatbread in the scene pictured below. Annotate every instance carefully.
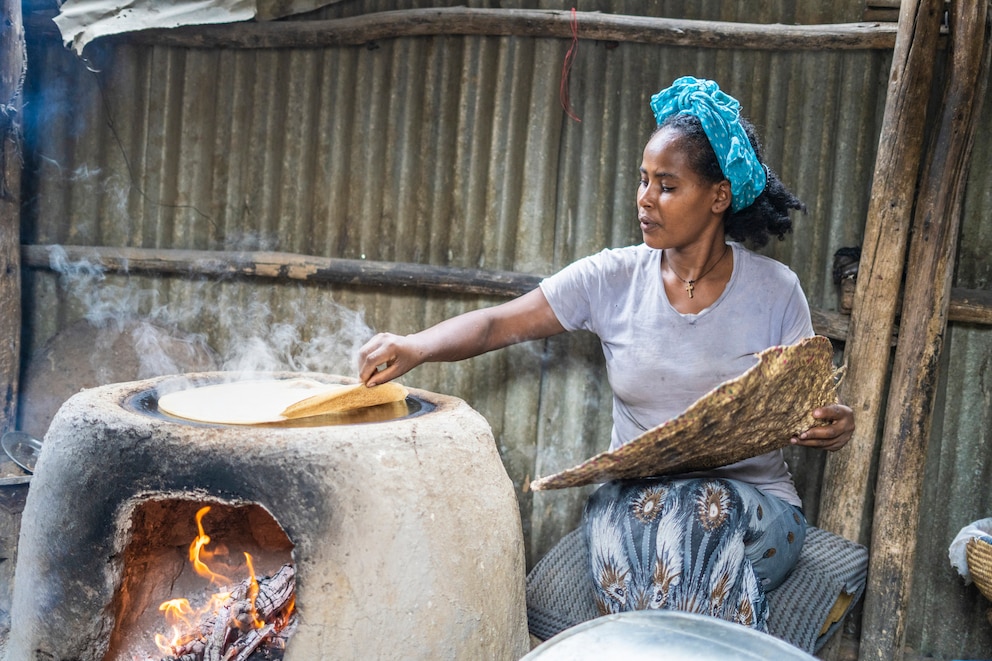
[358,287,565,387]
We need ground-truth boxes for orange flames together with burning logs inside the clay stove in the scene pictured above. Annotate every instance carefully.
[146,505,296,661]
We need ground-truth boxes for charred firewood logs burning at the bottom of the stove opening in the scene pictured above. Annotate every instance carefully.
[162,564,296,661]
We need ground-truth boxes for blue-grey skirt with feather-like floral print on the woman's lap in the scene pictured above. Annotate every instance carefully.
[583,478,806,632]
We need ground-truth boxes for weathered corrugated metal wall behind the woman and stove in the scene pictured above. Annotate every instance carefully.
[15,0,992,658]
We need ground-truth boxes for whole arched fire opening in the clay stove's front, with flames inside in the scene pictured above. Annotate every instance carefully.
[104,496,296,661]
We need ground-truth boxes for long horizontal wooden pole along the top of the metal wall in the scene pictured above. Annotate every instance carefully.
[28,7,897,51]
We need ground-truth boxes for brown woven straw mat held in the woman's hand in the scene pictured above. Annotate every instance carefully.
[530,335,838,491]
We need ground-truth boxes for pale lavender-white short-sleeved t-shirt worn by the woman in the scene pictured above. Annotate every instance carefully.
[540,243,813,505]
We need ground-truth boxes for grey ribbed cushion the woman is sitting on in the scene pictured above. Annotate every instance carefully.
[527,526,868,653]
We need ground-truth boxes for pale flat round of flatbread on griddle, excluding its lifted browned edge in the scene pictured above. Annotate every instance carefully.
[158,378,348,425]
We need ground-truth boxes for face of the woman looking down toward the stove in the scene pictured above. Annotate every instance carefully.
[637,128,730,249]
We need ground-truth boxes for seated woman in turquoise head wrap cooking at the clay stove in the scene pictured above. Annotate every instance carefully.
[359,76,854,631]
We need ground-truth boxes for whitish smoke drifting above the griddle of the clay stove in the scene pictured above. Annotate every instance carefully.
[42,246,372,379]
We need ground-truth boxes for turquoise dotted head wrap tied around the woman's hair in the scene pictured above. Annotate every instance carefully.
[651,76,767,213]
